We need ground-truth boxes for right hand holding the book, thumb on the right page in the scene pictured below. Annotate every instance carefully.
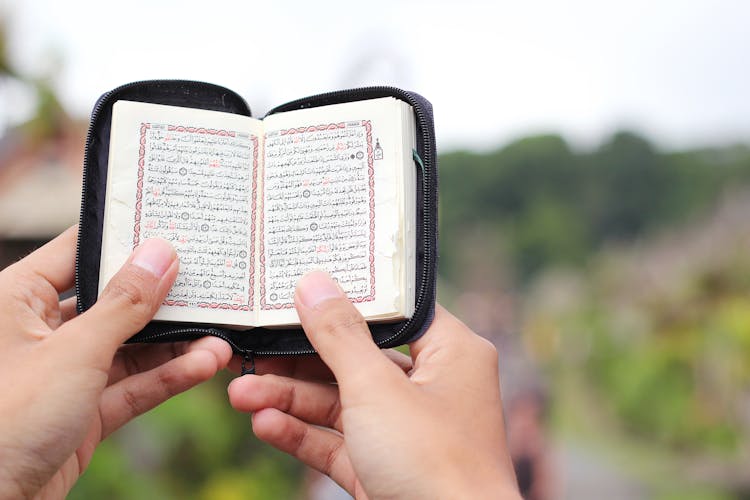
[228,272,520,499]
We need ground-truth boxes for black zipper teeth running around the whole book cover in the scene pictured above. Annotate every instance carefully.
[75,80,432,356]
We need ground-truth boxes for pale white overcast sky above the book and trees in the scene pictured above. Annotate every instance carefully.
[0,0,750,150]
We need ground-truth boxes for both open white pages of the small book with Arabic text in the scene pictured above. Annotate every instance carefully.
[99,97,416,327]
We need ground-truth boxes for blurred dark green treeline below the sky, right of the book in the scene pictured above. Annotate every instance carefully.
[440,132,750,283]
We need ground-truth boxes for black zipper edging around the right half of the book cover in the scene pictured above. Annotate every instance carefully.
[268,86,437,355]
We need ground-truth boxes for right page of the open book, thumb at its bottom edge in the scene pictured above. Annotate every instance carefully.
[258,98,413,324]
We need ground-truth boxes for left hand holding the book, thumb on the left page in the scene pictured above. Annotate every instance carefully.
[0,228,231,498]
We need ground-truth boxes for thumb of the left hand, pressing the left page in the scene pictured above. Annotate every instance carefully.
[56,238,179,367]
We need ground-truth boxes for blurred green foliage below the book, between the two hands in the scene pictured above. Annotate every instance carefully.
[69,373,303,500]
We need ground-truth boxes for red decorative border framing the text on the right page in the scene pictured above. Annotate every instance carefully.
[259,120,375,311]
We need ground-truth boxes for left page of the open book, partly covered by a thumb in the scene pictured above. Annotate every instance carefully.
[99,101,262,325]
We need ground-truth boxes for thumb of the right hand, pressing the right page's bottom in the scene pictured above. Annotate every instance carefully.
[294,271,404,391]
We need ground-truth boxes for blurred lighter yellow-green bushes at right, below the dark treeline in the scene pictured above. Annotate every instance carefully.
[523,232,750,498]
